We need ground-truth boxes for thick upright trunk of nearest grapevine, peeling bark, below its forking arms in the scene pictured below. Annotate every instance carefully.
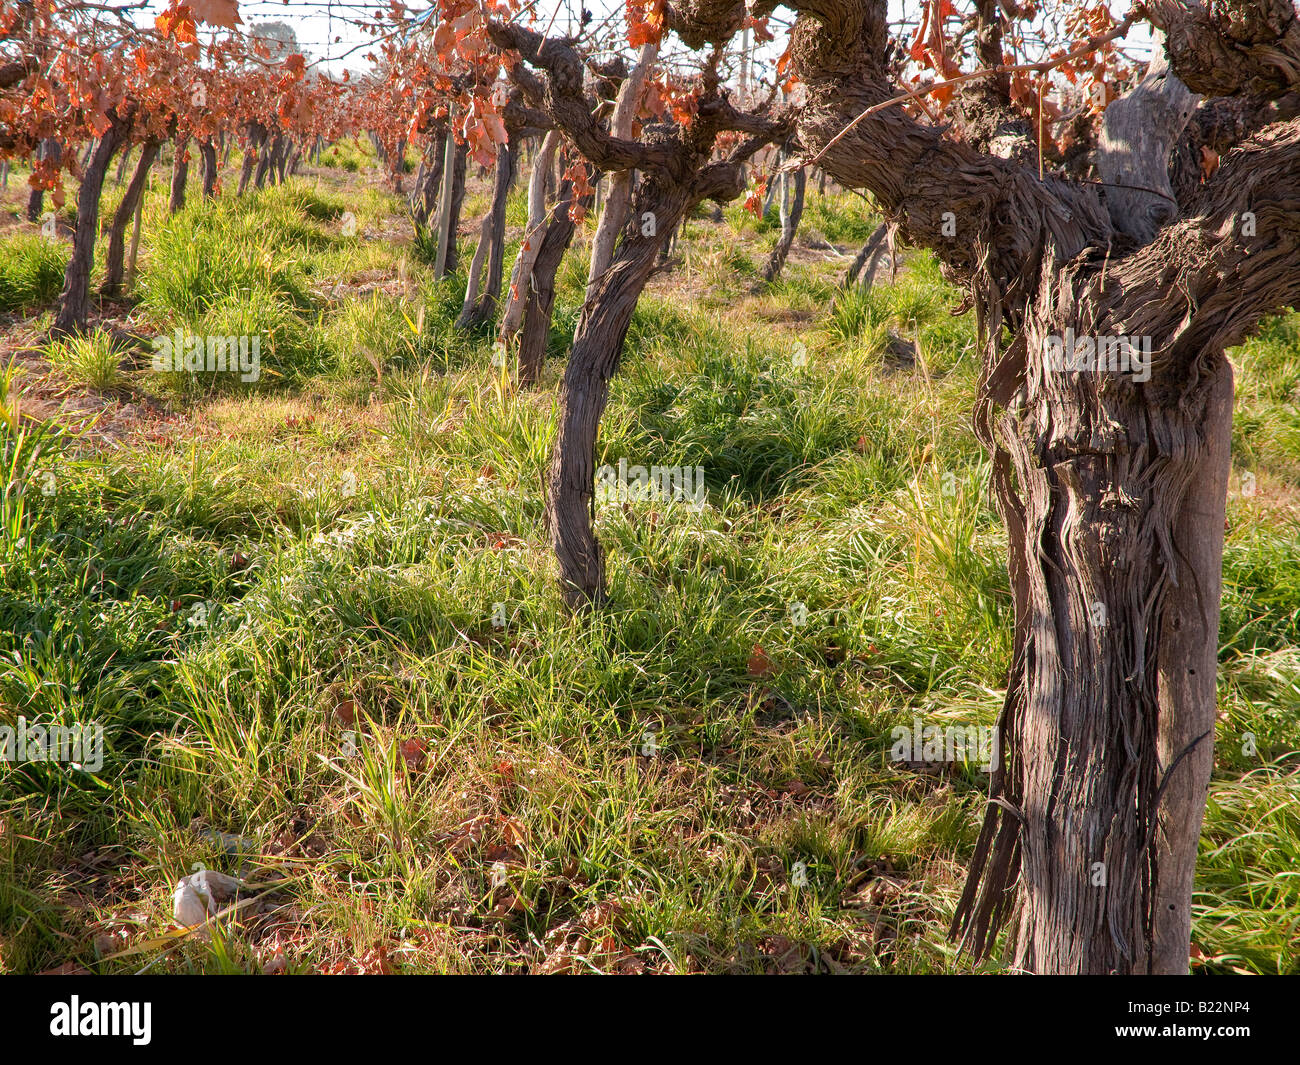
[957,287,1231,974]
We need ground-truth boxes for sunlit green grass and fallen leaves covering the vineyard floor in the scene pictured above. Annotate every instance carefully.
[0,146,1300,973]
